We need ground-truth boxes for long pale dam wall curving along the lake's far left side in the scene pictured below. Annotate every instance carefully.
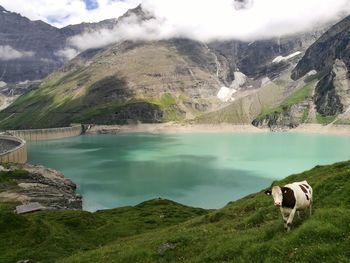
[7,124,83,141]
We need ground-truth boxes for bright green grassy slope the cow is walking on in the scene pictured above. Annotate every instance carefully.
[58,162,350,262]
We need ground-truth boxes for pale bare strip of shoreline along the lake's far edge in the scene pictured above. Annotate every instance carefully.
[86,123,350,135]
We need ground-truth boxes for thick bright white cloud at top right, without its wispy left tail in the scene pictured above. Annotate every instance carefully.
[139,0,350,41]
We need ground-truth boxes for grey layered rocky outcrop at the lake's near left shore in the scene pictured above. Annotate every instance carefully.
[0,164,82,209]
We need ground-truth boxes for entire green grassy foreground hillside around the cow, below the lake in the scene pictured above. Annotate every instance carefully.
[0,161,350,263]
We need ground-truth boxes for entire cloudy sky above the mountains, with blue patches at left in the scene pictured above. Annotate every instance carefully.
[0,0,350,54]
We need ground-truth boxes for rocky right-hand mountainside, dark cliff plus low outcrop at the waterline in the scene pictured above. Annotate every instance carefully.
[253,16,350,129]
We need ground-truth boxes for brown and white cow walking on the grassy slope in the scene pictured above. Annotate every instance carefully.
[265,181,312,231]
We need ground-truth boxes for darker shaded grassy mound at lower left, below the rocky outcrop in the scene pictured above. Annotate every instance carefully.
[0,200,208,263]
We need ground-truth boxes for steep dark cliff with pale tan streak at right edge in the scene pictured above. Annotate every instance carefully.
[292,16,350,119]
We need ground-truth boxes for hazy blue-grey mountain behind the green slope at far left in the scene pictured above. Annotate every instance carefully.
[0,6,116,83]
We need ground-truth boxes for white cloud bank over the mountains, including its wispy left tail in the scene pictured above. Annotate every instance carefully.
[65,0,350,53]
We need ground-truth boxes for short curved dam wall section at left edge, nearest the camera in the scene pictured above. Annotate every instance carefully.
[0,135,27,164]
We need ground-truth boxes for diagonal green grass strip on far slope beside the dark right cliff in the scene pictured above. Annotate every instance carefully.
[256,82,314,121]
